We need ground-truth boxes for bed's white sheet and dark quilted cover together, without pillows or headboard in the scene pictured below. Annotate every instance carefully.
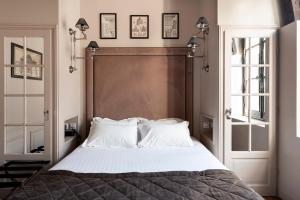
[11,139,262,200]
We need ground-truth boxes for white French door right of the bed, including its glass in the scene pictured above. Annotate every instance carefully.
[224,29,276,195]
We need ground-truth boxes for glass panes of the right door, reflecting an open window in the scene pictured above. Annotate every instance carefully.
[230,37,270,152]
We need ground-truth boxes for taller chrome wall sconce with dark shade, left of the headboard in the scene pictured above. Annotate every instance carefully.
[69,18,89,73]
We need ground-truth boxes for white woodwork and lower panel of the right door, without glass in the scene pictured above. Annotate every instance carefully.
[219,27,277,195]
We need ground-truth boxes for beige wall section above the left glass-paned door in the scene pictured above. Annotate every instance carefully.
[0,0,58,25]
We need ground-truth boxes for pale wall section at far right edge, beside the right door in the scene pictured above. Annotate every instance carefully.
[277,21,300,200]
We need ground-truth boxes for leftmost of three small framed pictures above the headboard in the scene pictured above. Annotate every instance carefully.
[100,13,117,39]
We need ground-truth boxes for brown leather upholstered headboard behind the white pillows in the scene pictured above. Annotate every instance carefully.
[86,47,193,134]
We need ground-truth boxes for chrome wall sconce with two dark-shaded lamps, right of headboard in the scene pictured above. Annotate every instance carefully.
[187,17,209,72]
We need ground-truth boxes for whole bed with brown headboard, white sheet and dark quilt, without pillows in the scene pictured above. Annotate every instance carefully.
[10,48,263,200]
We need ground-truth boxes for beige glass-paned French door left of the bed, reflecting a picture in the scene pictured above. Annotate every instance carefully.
[0,29,52,162]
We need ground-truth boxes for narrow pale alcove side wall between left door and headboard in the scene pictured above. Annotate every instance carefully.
[57,0,83,159]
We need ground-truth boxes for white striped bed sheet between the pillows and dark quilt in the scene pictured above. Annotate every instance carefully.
[50,140,227,173]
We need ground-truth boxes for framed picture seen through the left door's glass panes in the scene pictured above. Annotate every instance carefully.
[11,43,43,80]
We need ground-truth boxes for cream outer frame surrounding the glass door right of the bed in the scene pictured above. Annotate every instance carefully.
[219,26,279,195]
